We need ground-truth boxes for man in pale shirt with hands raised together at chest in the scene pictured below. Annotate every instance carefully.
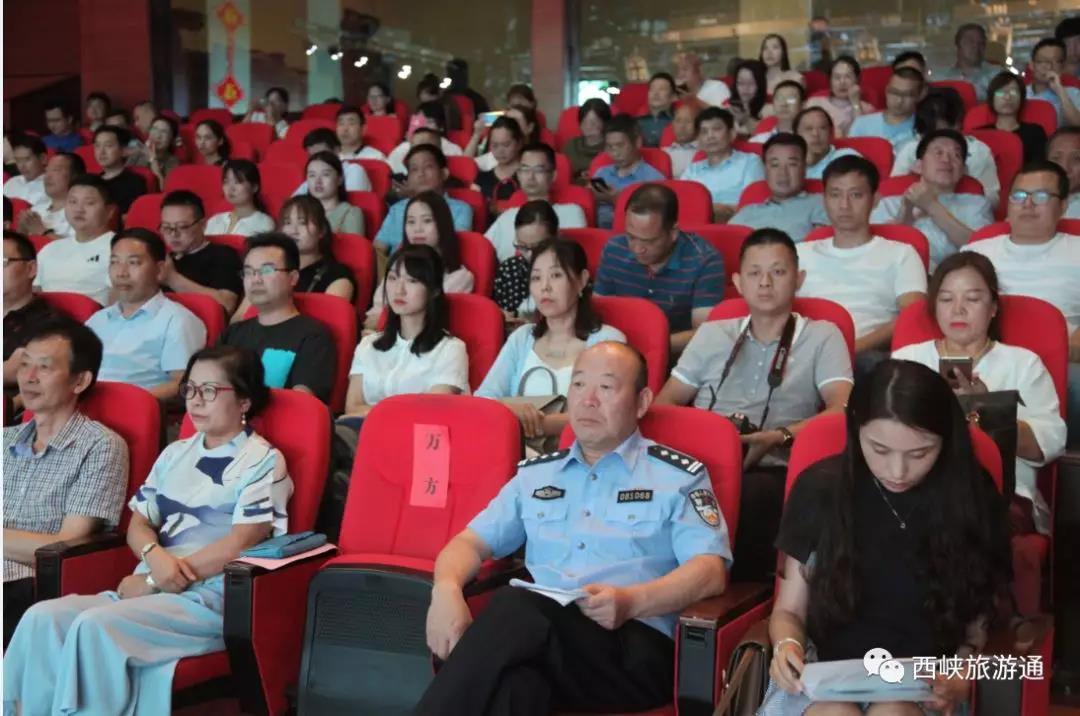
[870,130,994,272]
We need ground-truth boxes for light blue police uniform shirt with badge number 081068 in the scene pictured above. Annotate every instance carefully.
[469,431,731,636]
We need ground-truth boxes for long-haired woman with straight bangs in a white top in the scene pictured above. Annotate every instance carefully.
[345,244,469,418]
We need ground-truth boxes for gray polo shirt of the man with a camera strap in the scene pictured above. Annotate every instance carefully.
[672,314,851,430]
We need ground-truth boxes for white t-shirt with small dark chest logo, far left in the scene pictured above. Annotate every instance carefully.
[33,231,116,306]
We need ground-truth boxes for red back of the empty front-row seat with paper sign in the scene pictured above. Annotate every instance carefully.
[339,395,522,560]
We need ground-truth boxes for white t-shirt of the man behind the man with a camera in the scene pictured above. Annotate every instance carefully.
[797,237,927,338]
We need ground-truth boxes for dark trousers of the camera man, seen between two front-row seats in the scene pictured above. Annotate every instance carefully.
[731,465,787,582]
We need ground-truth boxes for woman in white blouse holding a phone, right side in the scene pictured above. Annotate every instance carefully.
[893,252,1065,535]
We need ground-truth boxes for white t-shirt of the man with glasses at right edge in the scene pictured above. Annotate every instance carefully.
[963,233,1080,336]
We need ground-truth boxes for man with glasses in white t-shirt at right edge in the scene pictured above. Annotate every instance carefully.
[964,161,1080,447]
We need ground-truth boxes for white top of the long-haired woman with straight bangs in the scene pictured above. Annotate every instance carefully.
[349,333,469,405]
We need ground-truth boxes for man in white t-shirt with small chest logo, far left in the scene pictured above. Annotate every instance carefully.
[33,174,117,306]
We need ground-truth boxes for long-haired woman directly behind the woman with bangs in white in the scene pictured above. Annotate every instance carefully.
[364,191,475,330]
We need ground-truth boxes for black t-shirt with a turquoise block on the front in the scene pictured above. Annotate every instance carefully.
[218,315,337,403]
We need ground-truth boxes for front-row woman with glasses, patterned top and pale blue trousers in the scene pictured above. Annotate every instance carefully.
[3,346,293,716]
